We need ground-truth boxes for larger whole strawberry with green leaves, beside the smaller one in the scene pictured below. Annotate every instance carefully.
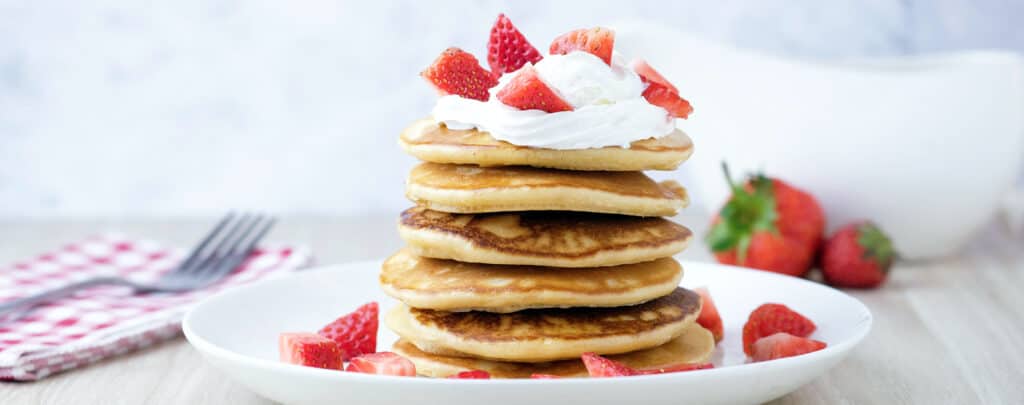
[705,164,825,277]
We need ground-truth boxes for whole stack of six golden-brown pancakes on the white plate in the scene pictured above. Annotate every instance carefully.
[380,120,715,377]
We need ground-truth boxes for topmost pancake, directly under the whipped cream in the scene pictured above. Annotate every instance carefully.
[398,119,693,172]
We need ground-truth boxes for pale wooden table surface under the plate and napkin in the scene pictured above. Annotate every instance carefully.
[0,216,1024,404]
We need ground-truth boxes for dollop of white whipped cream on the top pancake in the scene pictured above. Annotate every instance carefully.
[432,51,676,149]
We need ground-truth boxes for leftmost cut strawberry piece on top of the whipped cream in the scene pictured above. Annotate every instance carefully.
[420,48,498,101]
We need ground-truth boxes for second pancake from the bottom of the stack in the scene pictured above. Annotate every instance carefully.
[385,288,700,363]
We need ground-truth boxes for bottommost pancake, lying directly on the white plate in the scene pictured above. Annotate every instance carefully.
[391,322,715,378]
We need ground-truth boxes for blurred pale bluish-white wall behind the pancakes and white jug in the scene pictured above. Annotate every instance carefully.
[0,0,1024,217]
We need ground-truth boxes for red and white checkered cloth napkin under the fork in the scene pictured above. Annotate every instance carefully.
[0,235,311,380]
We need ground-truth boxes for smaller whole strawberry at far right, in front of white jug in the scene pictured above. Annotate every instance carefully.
[821,222,895,288]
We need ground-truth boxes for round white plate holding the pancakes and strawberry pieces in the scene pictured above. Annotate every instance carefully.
[182,261,871,405]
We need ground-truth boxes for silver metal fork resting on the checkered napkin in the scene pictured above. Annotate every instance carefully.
[0,213,274,319]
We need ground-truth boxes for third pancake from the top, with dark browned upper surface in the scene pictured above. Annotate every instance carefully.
[398,207,692,267]
